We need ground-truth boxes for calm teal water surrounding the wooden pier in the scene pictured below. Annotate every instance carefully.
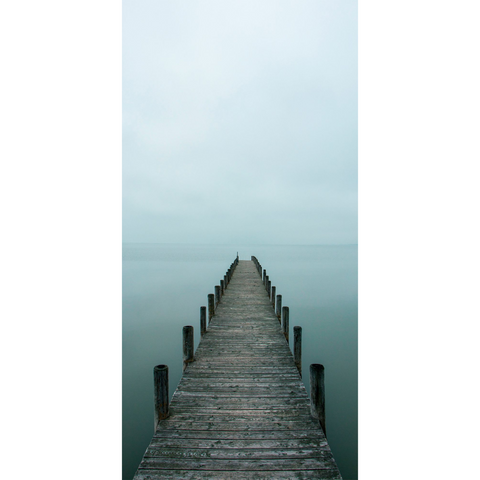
[123,244,358,480]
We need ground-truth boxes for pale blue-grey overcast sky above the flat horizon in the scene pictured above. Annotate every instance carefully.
[123,0,357,244]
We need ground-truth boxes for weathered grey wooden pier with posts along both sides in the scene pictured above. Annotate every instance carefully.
[134,256,342,480]
